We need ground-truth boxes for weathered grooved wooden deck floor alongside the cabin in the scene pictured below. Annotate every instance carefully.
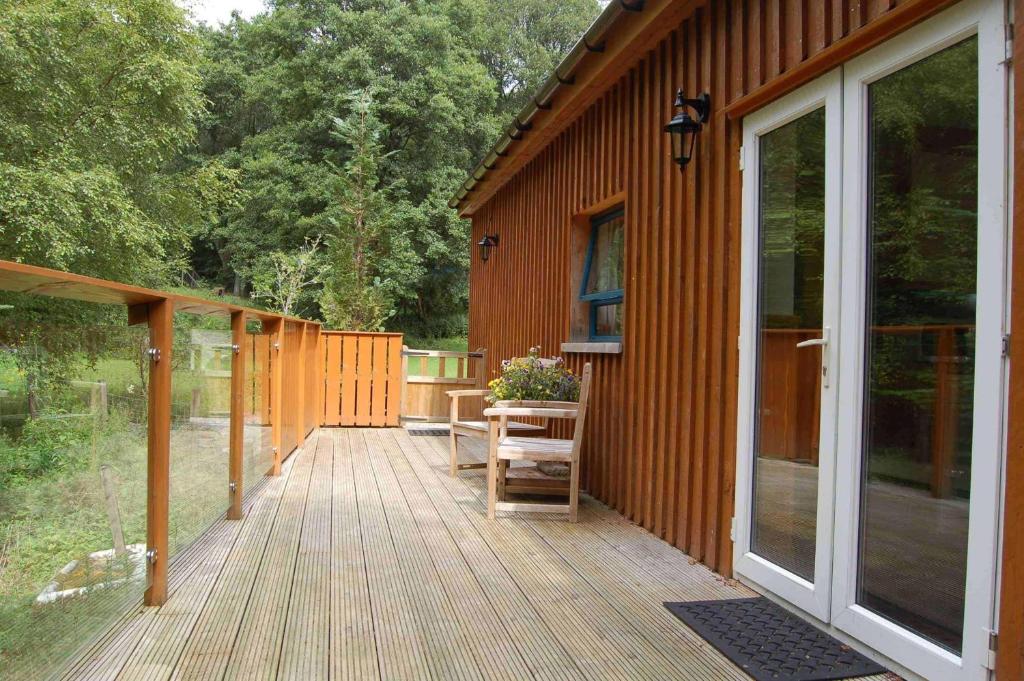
[66,429,851,680]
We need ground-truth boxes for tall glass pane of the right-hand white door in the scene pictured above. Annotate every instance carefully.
[858,38,978,652]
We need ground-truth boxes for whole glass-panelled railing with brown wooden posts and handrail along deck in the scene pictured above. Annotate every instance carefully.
[0,261,324,681]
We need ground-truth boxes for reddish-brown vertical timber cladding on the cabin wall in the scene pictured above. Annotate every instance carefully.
[470,0,933,574]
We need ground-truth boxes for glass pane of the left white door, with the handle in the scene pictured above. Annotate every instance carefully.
[751,109,825,582]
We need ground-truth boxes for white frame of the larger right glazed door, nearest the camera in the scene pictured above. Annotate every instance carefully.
[831,0,1008,681]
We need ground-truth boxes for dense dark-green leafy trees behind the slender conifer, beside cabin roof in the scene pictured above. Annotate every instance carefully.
[193,0,596,335]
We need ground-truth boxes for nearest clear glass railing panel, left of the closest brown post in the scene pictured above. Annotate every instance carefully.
[0,295,150,680]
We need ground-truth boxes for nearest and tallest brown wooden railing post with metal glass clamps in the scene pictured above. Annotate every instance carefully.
[143,299,174,605]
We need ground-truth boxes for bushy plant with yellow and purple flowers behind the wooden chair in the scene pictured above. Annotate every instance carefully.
[487,346,580,403]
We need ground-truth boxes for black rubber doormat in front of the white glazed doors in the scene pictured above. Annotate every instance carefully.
[665,598,886,681]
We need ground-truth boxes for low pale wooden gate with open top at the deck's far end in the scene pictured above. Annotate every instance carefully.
[401,348,487,423]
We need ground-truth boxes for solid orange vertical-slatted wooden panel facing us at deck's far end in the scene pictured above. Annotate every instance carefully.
[321,332,401,426]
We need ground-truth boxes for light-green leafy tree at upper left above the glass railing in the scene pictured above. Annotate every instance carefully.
[0,0,234,284]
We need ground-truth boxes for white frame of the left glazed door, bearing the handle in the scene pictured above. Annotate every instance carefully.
[733,69,843,622]
